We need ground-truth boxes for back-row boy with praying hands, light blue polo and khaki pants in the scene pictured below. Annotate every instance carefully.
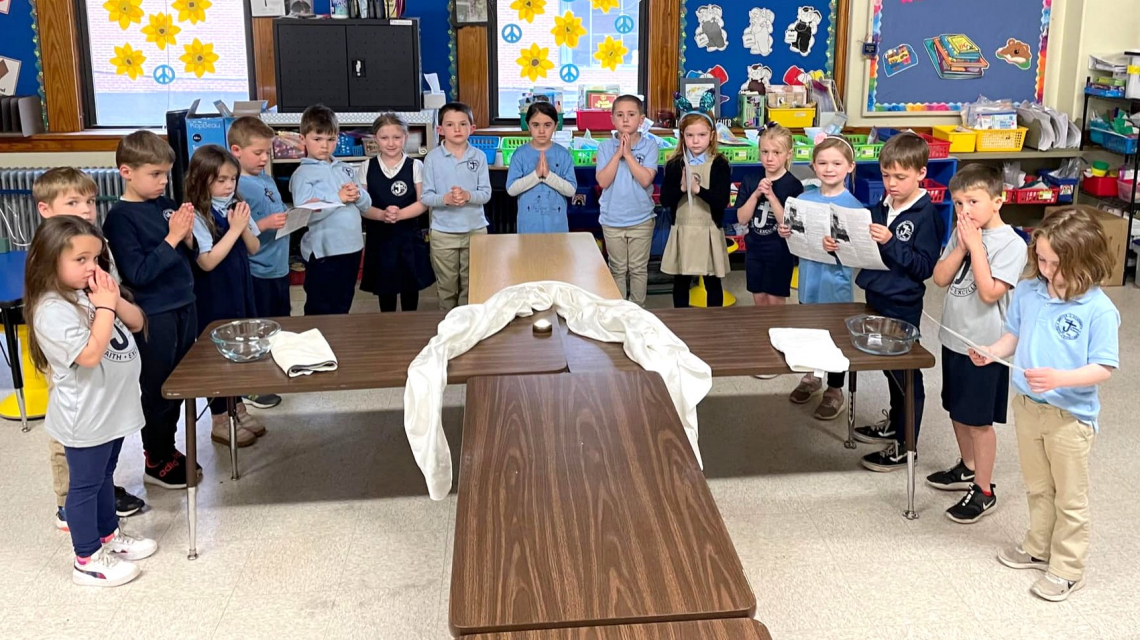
[597,95,658,307]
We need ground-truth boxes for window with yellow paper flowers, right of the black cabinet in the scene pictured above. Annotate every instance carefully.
[489,0,645,122]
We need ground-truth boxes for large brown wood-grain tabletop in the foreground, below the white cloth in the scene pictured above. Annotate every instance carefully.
[450,371,756,634]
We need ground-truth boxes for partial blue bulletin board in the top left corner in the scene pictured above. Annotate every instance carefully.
[0,0,43,107]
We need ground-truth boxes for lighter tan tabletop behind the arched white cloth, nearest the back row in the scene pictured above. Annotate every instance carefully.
[467,233,621,303]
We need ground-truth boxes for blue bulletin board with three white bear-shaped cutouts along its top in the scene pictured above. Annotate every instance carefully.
[681,0,834,118]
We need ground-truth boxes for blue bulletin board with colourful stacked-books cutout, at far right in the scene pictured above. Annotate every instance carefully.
[866,0,1052,114]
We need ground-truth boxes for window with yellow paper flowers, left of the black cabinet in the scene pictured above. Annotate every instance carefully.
[79,0,250,127]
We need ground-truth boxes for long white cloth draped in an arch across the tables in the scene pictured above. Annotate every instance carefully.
[404,282,713,500]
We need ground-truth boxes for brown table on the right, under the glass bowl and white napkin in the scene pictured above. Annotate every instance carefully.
[561,303,935,519]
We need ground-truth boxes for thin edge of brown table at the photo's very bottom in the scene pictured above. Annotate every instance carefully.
[467,618,772,640]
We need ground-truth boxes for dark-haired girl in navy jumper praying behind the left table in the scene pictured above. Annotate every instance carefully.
[186,145,266,447]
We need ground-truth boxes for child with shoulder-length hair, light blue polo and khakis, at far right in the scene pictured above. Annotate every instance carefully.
[970,208,1121,602]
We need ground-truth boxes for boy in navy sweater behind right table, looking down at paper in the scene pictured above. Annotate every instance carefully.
[855,132,946,471]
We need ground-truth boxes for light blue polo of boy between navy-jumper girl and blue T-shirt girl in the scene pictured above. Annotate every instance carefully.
[420,145,491,234]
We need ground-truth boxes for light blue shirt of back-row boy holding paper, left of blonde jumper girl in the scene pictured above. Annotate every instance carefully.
[288,157,372,260]
